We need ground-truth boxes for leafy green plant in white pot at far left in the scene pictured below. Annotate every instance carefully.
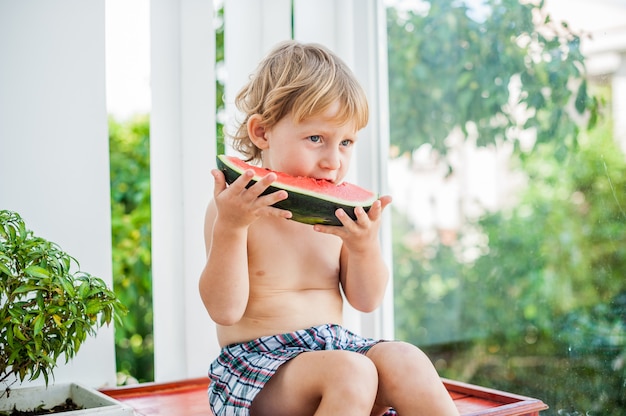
[0,210,132,415]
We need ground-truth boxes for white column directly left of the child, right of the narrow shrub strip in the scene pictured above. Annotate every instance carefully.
[150,0,218,381]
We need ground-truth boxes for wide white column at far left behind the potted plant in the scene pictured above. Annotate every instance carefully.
[0,0,115,387]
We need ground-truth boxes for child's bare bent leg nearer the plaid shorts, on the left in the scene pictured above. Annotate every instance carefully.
[250,350,378,416]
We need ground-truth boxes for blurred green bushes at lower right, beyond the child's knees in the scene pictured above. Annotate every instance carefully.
[394,114,626,415]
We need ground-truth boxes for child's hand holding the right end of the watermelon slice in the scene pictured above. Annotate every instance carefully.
[313,196,391,252]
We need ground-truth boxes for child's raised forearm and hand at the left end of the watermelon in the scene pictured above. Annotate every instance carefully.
[199,170,291,325]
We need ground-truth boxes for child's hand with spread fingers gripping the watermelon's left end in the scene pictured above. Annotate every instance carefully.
[211,169,291,227]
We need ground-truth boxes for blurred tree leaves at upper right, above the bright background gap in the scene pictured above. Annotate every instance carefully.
[387,0,597,157]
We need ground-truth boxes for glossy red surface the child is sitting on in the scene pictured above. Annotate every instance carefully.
[102,378,548,416]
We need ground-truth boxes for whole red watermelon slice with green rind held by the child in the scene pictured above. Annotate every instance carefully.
[217,155,378,225]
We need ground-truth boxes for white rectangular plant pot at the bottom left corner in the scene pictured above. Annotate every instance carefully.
[0,383,134,416]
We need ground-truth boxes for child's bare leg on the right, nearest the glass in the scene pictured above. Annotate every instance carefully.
[367,342,459,416]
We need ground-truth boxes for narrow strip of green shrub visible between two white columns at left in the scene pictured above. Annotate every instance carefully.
[109,116,154,384]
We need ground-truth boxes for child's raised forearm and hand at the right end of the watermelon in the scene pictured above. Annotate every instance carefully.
[315,196,391,312]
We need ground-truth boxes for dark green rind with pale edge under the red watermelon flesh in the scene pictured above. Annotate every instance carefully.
[217,155,377,226]
